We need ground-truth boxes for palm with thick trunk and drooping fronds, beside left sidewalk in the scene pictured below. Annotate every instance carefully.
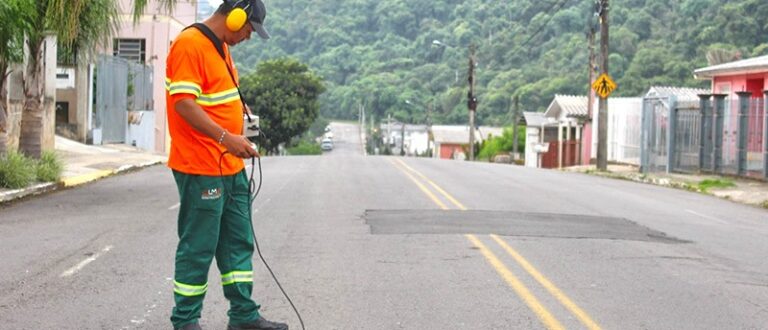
[18,0,118,158]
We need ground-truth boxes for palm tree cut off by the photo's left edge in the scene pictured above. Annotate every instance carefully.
[0,0,24,157]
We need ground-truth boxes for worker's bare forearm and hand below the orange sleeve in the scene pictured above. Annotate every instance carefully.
[174,98,259,158]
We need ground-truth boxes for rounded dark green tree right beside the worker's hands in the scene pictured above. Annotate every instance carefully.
[240,59,325,152]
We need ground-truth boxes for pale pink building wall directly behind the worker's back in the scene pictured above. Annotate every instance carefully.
[115,0,197,152]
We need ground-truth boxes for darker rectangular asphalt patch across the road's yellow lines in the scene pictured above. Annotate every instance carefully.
[363,210,689,243]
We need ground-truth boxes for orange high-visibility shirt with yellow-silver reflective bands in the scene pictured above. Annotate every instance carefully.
[165,28,244,176]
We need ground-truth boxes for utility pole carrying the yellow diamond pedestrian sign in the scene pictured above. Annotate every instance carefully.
[597,0,608,171]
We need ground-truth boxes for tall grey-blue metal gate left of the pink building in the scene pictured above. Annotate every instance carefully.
[93,56,128,143]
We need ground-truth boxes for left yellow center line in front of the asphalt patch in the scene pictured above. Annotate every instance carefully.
[465,235,565,329]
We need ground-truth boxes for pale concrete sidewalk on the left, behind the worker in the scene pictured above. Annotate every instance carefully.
[0,136,167,204]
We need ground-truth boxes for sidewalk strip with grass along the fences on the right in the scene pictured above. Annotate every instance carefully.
[563,165,768,209]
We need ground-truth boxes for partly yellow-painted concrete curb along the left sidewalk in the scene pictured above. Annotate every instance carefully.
[0,160,163,204]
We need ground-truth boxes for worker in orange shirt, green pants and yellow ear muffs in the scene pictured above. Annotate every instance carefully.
[166,0,288,330]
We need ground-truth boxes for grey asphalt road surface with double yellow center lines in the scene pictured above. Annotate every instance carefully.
[0,123,768,329]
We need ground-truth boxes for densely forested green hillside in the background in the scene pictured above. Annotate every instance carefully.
[234,0,768,125]
